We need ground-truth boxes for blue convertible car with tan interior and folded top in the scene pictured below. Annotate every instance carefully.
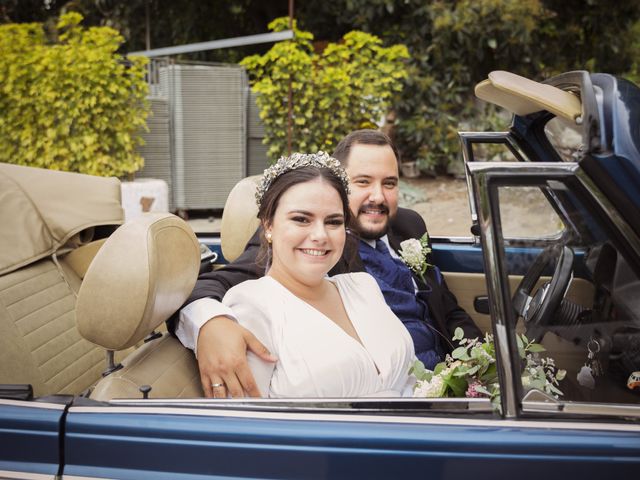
[0,72,640,480]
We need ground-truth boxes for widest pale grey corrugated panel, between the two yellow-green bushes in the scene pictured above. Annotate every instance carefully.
[160,65,247,209]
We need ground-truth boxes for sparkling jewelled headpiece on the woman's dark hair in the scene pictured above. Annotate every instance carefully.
[256,150,349,210]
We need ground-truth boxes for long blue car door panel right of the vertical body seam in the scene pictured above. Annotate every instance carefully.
[65,407,640,479]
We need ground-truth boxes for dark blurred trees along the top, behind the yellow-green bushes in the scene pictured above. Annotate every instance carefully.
[0,0,640,173]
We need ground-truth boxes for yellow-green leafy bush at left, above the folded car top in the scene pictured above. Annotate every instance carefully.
[0,13,148,176]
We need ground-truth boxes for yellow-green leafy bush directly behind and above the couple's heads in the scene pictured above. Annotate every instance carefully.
[241,18,408,160]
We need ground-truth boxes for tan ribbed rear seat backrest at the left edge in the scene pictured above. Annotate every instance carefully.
[0,253,105,397]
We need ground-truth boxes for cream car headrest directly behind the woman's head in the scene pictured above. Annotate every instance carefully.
[220,175,261,262]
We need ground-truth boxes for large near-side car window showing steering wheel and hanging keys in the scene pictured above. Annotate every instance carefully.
[500,181,640,404]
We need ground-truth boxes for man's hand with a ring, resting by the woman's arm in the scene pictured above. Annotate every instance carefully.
[197,316,276,398]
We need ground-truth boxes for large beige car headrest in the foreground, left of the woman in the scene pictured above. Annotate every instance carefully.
[76,213,200,350]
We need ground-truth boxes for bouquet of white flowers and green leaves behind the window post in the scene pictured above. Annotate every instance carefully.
[410,328,566,410]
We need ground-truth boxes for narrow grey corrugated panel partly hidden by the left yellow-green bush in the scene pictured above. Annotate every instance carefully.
[136,97,174,210]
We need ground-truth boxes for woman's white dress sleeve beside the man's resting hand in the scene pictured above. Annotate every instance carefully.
[222,282,278,397]
